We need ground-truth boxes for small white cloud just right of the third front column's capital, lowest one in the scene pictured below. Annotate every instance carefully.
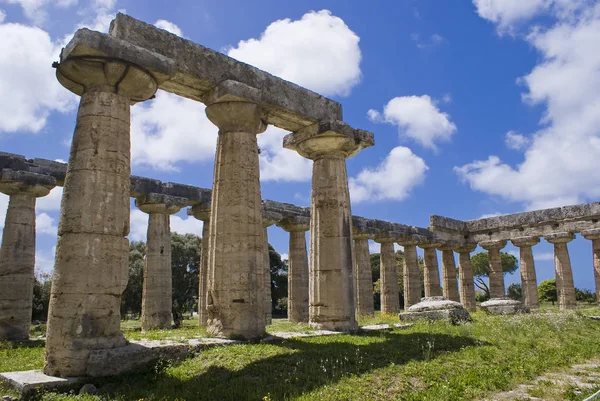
[349,146,428,203]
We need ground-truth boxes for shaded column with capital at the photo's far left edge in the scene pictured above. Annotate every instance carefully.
[0,173,56,341]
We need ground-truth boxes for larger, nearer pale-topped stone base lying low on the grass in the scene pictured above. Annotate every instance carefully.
[400,297,471,324]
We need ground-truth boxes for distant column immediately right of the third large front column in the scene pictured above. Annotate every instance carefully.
[353,234,374,316]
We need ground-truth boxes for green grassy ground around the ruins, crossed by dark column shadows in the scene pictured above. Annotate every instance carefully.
[0,308,600,401]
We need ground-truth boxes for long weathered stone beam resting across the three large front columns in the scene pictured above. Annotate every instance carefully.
[109,13,342,131]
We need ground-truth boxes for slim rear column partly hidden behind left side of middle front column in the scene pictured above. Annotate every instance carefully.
[188,203,210,327]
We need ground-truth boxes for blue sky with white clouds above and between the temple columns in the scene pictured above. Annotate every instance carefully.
[0,0,600,289]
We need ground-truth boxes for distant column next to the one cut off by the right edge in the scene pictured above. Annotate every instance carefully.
[544,233,577,310]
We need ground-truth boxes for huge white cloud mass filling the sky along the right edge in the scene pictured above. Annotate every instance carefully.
[455,3,600,209]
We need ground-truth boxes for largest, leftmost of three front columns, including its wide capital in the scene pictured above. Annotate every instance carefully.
[44,29,173,377]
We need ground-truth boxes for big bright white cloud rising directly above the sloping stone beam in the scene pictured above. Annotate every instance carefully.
[227,10,362,96]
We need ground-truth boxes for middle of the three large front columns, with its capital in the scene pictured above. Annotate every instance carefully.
[206,81,267,339]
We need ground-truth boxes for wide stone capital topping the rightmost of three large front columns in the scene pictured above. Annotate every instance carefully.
[283,120,375,159]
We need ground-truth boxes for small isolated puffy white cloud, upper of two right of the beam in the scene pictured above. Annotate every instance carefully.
[367,95,456,149]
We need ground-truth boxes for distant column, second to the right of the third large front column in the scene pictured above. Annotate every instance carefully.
[375,238,398,315]
